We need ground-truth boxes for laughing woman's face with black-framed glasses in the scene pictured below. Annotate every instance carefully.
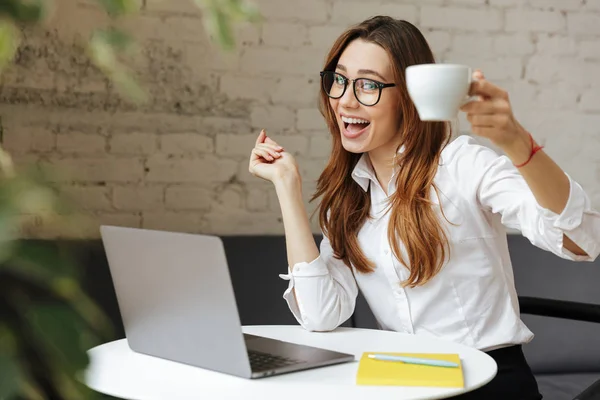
[329,39,400,154]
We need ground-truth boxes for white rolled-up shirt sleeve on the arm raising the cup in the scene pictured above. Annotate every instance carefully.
[472,141,600,261]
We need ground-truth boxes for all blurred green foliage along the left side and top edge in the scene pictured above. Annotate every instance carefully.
[0,0,259,400]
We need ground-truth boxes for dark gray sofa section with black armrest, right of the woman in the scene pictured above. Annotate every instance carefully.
[509,235,600,400]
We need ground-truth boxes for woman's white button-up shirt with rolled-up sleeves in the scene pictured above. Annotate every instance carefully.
[281,136,600,350]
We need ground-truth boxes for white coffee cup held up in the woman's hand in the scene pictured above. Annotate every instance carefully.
[406,64,472,121]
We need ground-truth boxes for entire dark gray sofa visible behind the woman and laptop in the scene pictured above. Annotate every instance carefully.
[76,235,600,400]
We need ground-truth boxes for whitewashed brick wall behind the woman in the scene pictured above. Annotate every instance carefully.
[0,0,600,237]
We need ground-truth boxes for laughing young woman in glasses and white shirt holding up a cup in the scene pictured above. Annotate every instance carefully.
[249,17,600,399]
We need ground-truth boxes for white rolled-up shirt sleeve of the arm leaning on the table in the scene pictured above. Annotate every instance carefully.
[280,237,358,331]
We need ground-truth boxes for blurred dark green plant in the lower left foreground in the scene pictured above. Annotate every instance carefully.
[0,145,110,400]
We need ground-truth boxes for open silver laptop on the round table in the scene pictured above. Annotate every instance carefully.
[100,226,354,378]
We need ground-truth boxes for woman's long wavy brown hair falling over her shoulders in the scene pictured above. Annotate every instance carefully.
[311,16,450,287]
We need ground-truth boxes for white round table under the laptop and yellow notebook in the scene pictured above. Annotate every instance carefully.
[85,326,497,400]
